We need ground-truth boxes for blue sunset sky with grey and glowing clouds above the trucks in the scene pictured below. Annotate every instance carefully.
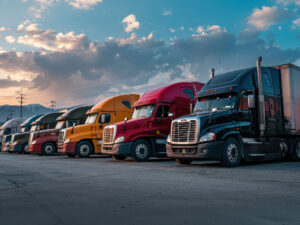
[0,0,300,108]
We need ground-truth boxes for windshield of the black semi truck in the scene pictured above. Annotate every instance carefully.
[195,94,236,112]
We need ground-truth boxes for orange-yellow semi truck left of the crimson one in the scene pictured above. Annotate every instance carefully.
[58,94,140,158]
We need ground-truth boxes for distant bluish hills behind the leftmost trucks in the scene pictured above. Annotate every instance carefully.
[0,104,62,124]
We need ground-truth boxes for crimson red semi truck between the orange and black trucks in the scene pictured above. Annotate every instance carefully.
[102,82,203,162]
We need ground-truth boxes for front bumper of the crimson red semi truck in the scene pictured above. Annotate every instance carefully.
[101,142,133,156]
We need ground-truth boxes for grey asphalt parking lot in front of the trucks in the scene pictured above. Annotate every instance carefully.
[0,153,300,225]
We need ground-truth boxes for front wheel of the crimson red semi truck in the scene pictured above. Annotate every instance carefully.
[131,139,151,162]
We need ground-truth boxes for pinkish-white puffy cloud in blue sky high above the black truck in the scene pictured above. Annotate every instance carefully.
[248,6,291,31]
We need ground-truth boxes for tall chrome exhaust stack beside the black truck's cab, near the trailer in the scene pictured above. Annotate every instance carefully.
[256,56,266,136]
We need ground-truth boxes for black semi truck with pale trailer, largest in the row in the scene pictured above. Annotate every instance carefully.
[166,57,300,166]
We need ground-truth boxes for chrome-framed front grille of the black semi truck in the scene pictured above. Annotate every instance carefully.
[171,119,197,144]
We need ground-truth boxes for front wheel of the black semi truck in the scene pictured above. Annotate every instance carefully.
[221,137,242,167]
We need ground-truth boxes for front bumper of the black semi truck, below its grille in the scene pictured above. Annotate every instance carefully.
[166,141,224,161]
